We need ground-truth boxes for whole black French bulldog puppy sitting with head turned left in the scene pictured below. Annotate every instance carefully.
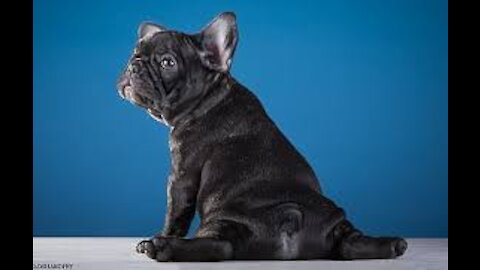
[118,12,407,261]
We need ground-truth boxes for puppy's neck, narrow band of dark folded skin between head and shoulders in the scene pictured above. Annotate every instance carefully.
[163,73,236,130]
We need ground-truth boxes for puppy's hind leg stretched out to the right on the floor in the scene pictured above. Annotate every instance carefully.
[333,220,407,260]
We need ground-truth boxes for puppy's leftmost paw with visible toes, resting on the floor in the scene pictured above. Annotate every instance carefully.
[137,236,172,262]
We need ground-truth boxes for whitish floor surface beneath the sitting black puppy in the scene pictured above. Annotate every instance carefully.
[33,237,448,270]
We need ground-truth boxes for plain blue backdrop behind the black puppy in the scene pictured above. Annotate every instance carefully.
[33,0,448,237]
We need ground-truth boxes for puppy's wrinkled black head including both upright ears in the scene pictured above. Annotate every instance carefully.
[117,13,238,125]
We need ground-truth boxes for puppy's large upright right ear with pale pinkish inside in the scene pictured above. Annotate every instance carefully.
[196,12,238,72]
